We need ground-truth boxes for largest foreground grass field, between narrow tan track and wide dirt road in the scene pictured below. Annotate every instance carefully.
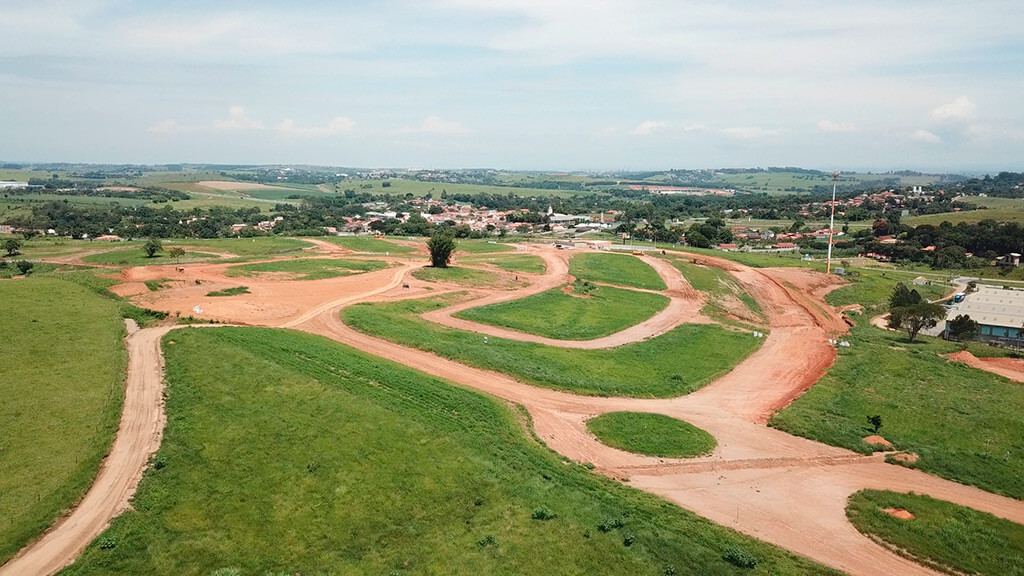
[63,328,827,576]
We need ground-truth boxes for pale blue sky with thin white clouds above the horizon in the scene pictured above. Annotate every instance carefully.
[0,0,1024,171]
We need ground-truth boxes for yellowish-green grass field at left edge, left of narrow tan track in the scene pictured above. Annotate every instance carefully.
[0,277,125,564]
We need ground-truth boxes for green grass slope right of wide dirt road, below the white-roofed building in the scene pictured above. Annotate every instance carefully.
[770,322,1024,498]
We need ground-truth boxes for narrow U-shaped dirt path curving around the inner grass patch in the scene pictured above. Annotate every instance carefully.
[422,247,711,349]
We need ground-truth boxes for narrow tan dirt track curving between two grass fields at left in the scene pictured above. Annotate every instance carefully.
[0,323,171,576]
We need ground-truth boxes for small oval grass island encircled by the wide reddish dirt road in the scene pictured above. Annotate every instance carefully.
[587,412,718,458]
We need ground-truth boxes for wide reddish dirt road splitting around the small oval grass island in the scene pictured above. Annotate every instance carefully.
[297,248,1024,574]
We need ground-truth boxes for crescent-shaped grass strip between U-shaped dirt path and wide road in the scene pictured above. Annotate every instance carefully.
[341,295,763,398]
